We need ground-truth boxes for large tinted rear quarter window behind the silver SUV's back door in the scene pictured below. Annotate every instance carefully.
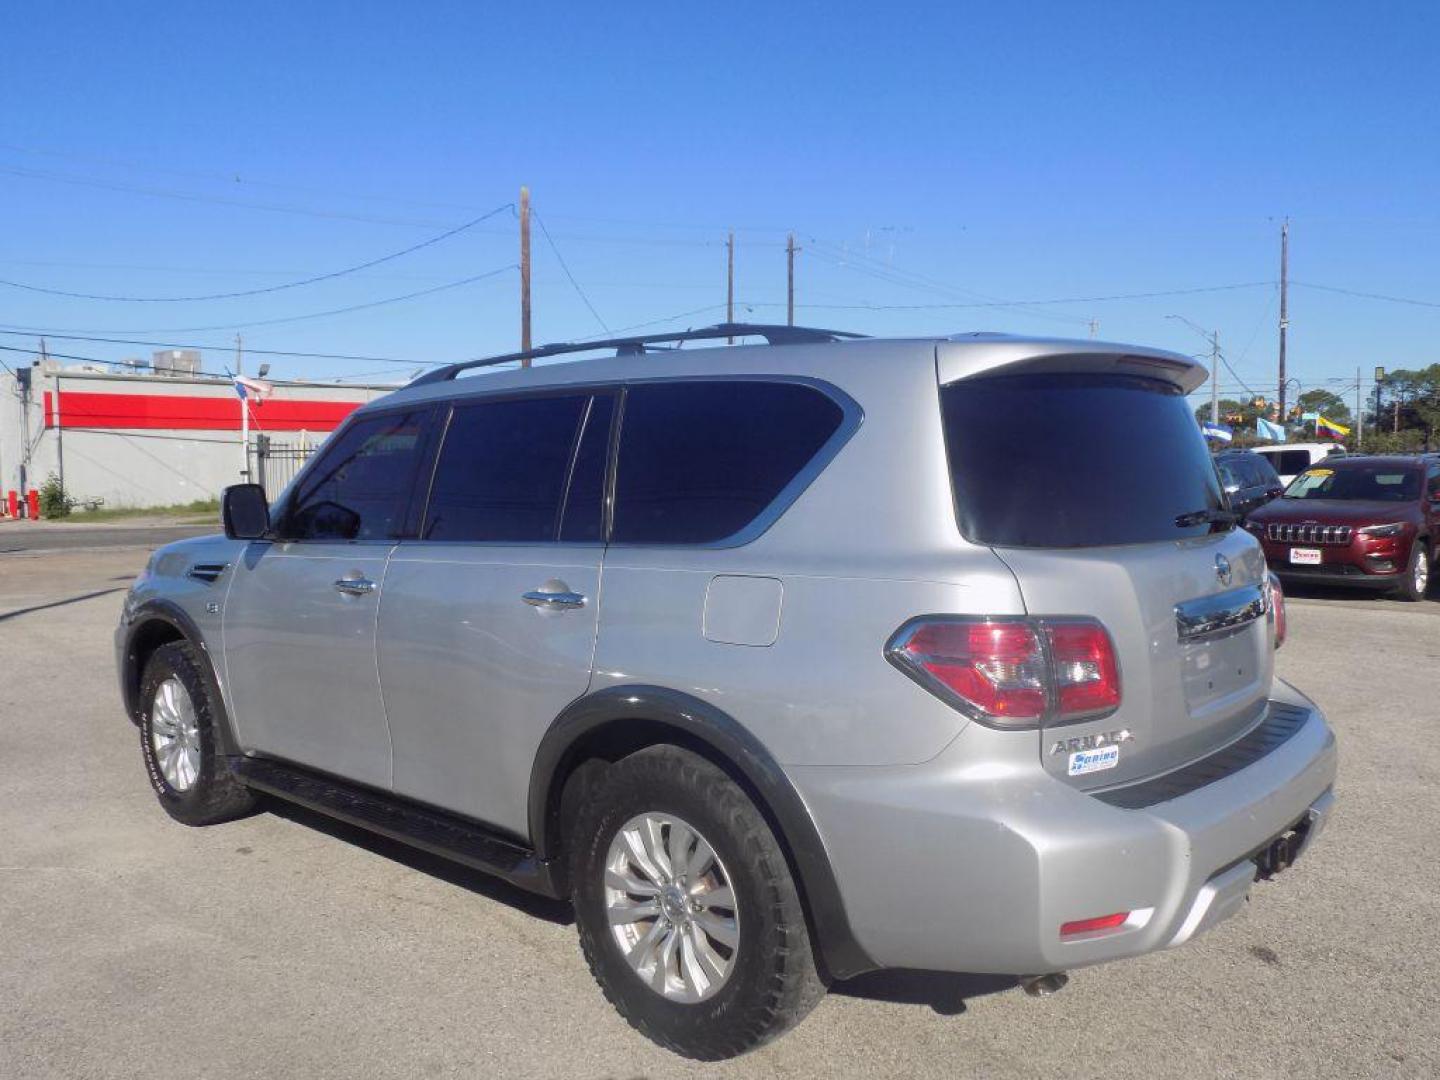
[612,382,844,544]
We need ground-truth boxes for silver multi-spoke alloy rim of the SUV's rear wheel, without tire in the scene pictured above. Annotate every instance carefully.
[605,812,740,1004]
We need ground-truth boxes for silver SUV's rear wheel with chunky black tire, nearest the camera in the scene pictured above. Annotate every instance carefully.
[570,746,825,1061]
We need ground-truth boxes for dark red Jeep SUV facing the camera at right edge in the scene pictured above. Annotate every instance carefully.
[1244,454,1440,600]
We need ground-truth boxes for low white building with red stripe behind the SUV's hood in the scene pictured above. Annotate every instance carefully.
[0,360,396,513]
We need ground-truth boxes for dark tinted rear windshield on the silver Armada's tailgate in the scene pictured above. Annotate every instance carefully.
[940,374,1224,547]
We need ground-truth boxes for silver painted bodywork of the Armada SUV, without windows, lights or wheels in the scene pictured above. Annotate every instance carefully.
[118,334,1336,973]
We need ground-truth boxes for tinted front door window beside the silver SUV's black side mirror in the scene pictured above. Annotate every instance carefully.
[281,409,431,540]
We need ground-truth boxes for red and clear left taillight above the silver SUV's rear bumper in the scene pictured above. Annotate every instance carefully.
[886,616,1120,727]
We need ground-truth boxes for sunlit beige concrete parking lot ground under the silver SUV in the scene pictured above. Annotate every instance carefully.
[0,536,1440,1080]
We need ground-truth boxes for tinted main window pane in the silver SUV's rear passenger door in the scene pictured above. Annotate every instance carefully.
[420,395,589,543]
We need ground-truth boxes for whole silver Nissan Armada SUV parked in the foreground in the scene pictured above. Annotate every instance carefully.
[117,325,1336,1058]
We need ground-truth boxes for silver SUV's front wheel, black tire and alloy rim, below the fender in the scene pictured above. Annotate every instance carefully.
[140,641,255,825]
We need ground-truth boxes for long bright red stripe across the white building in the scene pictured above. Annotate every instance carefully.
[45,390,361,432]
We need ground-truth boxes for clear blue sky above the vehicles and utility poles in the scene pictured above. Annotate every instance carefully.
[0,3,1440,403]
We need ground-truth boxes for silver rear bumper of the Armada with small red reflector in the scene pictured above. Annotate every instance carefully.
[791,683,1336,975]
